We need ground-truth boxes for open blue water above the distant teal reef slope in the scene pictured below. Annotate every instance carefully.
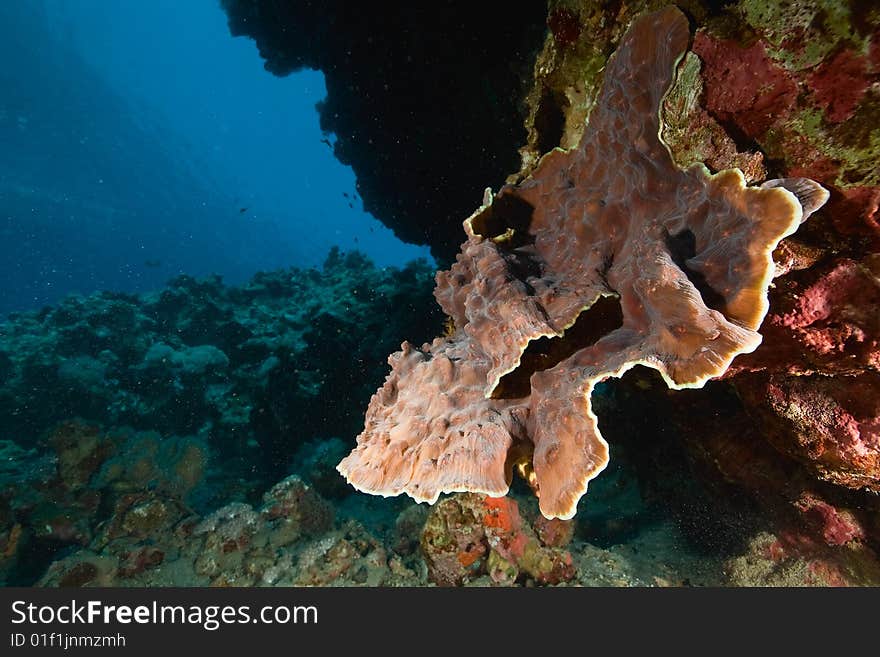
[0,0,429,316]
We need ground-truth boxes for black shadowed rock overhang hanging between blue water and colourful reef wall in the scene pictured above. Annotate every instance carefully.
[222,0,546,261]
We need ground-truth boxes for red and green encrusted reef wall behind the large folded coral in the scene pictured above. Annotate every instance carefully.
[511,0,880,564]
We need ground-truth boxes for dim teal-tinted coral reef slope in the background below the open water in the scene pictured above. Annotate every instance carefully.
[0,250,440,578]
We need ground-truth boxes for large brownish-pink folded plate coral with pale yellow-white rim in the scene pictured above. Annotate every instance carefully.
[338,7,828,518]
